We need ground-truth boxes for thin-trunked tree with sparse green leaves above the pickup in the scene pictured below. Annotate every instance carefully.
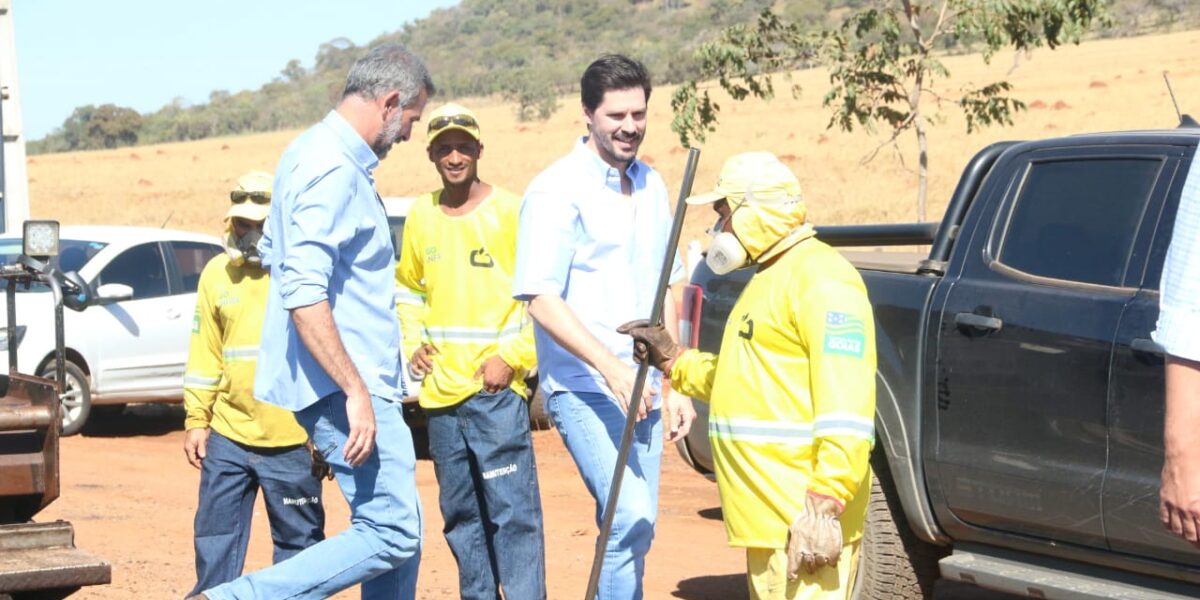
[671,0,1108,221]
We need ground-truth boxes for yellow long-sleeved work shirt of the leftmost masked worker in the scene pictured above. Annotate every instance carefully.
[184,253,308,448]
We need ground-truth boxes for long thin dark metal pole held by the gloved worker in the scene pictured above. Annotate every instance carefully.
[583,148,700,600]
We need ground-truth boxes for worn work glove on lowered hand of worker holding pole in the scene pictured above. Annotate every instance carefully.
[787,492,842,581]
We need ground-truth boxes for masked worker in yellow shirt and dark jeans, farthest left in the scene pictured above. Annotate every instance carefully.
[184,170,325,596]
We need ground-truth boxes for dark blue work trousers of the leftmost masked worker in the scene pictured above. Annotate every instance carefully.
[188,430,325,595]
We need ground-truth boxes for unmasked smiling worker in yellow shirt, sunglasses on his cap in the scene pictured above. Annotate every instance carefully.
[396,104,546,600]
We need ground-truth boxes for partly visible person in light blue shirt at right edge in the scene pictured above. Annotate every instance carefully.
[1154,152,1200,547]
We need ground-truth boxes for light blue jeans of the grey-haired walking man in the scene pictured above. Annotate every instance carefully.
[204,392,424,600]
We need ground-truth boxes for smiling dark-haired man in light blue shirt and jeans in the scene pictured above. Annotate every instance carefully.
[512,55,696,600]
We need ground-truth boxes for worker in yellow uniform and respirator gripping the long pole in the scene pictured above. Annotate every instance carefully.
[619,152,875,600]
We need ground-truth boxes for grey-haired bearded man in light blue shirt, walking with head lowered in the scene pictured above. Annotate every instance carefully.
[202,44,434,600]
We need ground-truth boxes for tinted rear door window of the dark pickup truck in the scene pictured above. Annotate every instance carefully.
[998,158,1163,286]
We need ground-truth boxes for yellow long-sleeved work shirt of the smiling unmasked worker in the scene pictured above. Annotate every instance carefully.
[396,187,536,408]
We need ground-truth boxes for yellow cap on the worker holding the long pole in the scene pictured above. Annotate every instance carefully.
[686,152,800,204]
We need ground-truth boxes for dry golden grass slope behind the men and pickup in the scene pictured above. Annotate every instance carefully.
[29,31,1200,246]
